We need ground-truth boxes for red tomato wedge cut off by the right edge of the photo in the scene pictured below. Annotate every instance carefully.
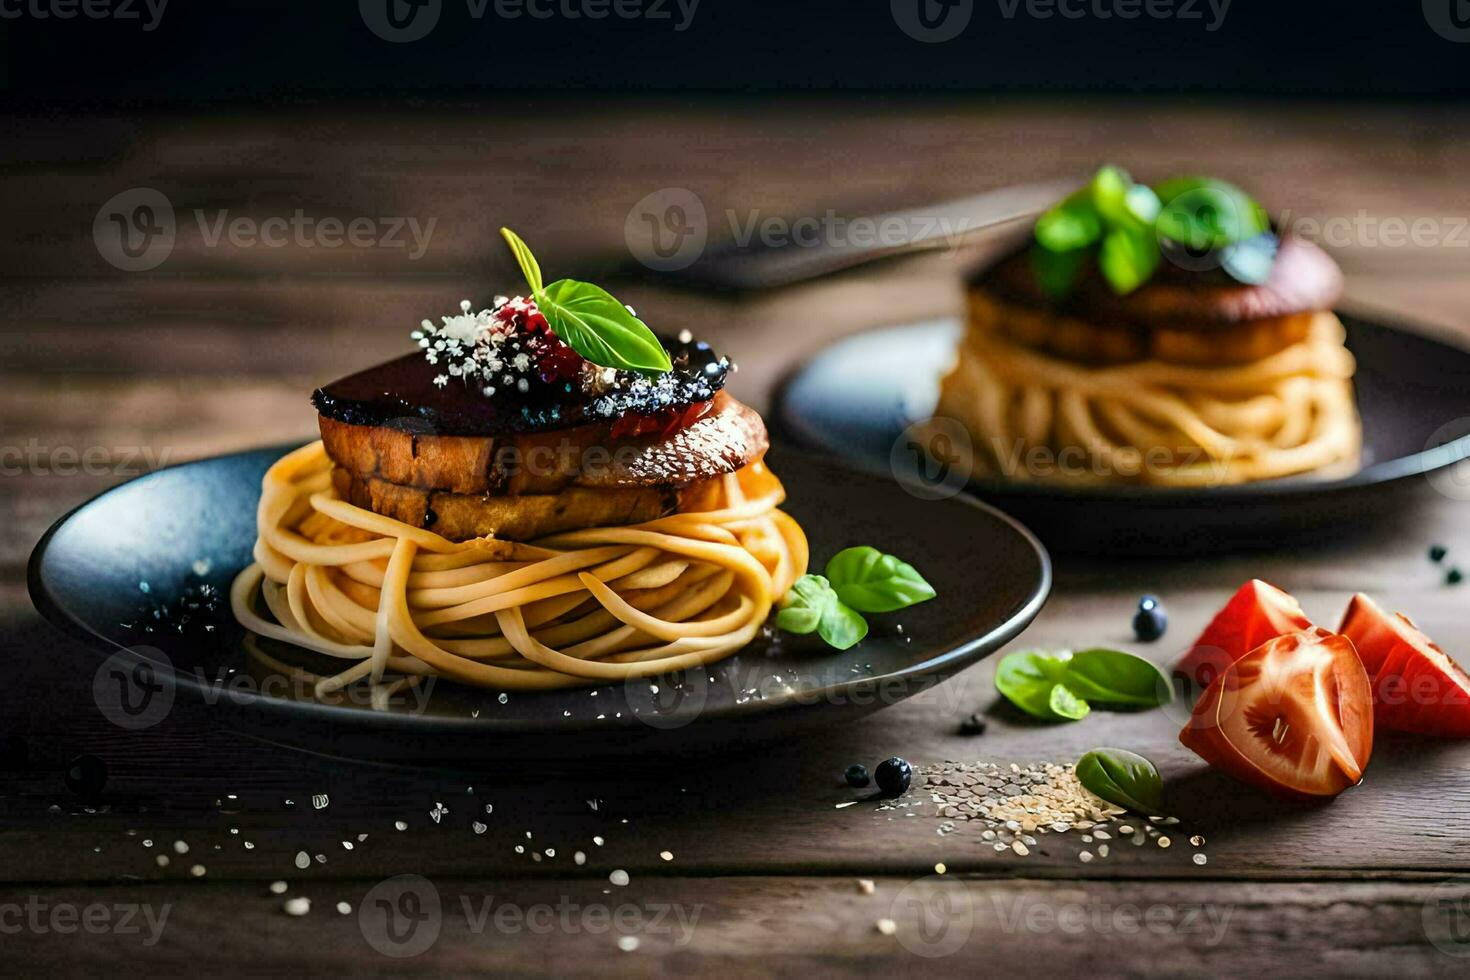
[1338,592,1470,738]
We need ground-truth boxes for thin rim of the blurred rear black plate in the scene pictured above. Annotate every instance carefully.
[769,304,1470,507]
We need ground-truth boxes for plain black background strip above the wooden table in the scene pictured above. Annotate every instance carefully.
[0,0,1470,107]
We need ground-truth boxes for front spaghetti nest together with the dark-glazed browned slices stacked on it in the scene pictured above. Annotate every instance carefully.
[231,326,807,695]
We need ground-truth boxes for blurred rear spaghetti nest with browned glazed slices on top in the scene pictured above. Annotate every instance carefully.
[931,237,1361,486]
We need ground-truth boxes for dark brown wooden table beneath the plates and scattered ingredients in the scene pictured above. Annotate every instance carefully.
[0,100,1470,976]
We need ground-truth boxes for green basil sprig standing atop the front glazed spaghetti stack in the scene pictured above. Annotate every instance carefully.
[500,228,673,375]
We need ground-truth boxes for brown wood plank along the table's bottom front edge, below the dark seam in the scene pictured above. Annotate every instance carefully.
[0,876,1467,977]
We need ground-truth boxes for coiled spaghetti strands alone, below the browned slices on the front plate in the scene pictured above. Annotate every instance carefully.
[231,442,807,693]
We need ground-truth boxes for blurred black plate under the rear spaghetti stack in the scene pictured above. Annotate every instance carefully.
[773,316,1470,555]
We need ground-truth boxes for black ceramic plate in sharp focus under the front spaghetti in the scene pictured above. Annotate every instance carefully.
[29,448,1051,761]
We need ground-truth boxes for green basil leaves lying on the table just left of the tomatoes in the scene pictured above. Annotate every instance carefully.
[995,648,1173,721]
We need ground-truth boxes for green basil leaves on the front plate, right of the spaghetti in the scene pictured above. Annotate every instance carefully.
[776,545,935,649]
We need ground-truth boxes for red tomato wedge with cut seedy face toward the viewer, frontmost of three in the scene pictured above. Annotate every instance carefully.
[1179,629,1373,798]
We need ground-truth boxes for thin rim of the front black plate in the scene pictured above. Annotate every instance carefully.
[26,441,1054,736]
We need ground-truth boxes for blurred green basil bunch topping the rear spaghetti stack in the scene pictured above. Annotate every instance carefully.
[1030,166,1276,298]
